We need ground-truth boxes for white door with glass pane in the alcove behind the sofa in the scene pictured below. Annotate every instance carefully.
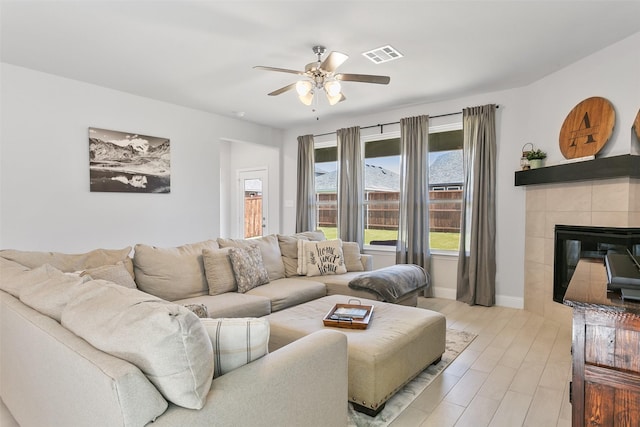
[238,169,269,239]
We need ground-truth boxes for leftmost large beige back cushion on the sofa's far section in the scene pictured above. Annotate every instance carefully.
[133,240,218,301]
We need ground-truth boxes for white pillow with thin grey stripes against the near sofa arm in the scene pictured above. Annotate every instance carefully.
[200,317,269,377]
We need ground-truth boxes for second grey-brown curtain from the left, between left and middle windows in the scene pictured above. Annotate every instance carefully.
[336,126,364,248]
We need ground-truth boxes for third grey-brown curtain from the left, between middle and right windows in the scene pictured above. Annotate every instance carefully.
[396,116,433,297]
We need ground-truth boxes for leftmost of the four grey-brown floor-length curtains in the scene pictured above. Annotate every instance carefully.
[296,135,317,233]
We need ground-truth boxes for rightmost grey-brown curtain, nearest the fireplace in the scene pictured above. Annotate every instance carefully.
[456,105,496,307]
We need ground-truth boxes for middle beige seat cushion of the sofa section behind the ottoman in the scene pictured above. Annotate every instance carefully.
[247,277,327,313]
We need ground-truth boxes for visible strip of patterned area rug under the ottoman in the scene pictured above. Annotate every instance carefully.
[348,329,476,427]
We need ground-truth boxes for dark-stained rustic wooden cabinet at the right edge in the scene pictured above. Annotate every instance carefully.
[564,260,640,427]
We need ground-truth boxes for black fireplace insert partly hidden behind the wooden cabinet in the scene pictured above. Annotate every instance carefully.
[553,225,640,303]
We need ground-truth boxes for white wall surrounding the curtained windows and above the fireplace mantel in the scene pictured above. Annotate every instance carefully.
[282,33,640,307]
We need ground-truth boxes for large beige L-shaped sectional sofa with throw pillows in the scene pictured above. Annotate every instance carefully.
[0,232,410,426]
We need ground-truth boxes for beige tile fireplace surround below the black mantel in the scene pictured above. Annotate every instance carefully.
[516,165,640,323]
